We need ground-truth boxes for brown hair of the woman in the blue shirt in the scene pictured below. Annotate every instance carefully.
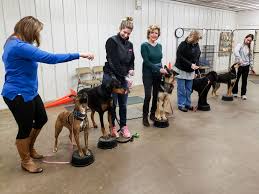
[11,16,43,46]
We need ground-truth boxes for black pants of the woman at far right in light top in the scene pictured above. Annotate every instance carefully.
[232,65,249,96]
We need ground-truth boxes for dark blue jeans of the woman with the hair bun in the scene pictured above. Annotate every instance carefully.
[103,74,128,128]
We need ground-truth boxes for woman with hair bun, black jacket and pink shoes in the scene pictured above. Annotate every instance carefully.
[103,17,135,138]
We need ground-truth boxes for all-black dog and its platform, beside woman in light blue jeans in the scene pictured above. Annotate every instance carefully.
[192,71,218,111]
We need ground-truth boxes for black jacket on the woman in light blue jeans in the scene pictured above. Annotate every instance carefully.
[175,40,201,72]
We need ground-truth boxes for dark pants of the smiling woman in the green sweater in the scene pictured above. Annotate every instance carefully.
[142,75,161,117]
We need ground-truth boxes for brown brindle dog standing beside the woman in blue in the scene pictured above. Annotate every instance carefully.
[53,94,89,157]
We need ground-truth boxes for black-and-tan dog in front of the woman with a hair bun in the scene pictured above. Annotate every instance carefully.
[78,77,127,138]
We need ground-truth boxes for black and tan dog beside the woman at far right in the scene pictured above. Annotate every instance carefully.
[212,63,240,96]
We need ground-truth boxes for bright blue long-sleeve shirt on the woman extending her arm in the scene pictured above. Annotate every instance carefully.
[1,37,79,102]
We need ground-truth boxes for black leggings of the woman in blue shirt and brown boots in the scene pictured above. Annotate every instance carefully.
[4,95,48,139]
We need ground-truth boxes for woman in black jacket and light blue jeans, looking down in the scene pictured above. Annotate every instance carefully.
[174,31,201,112]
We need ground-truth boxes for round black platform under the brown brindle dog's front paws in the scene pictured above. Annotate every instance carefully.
[71,150,94,167]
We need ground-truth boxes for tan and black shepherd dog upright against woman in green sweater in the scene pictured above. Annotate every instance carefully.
[155,67,177,120]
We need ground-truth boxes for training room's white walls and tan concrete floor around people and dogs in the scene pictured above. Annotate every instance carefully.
[0,0,259,194]
